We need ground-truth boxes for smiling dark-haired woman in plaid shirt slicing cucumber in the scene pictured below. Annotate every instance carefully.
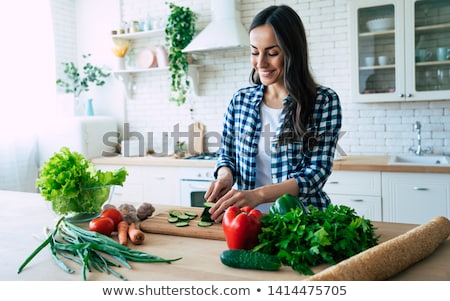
[205,5,342,222]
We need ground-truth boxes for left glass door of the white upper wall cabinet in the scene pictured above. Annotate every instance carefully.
[351,0,405,102]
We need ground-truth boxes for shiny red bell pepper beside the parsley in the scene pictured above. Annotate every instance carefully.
[222,206,262,250]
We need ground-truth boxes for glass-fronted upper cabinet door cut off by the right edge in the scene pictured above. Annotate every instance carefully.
[405,0,450,100]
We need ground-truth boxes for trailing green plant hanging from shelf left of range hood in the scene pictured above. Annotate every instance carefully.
[165,3,197,105]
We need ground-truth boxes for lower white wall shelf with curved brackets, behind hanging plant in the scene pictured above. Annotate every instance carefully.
[113,64,200,98]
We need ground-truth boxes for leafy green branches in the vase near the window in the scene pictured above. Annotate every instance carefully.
[56,53,111,114]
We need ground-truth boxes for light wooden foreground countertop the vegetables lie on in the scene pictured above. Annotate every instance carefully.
[0,191,450,281]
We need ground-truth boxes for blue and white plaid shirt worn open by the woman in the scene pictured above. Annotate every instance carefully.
[215,85,342,209]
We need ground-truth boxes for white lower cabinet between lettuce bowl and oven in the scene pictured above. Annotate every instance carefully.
[95,164,180,206]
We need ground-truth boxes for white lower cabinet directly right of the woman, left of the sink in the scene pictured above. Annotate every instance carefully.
[324,171,382,221]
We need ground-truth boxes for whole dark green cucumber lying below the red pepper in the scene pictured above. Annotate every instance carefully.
[220,250,281,271]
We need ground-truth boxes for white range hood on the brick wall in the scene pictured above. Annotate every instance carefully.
[183,0,249,52]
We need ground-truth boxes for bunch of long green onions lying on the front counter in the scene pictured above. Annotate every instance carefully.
[17,218,181,280]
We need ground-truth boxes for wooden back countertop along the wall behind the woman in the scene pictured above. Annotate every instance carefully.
[92,156,450,174]
